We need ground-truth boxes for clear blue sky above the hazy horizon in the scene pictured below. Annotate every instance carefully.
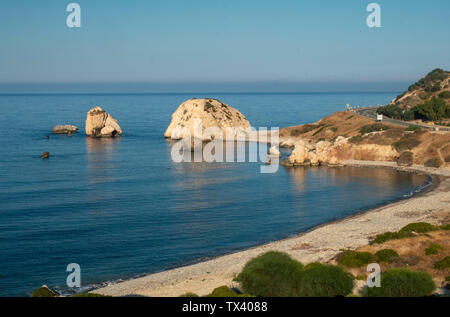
[0,0,450,90]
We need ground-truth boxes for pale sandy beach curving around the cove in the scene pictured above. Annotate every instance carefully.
[93,161,450,297]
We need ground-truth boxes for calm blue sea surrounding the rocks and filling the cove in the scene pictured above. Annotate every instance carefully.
[0,93,426,296]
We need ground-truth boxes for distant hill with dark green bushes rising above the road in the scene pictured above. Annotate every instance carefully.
[377,68,450,125]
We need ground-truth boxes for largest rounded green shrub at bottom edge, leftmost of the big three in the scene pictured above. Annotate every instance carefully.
[236,251,303,297]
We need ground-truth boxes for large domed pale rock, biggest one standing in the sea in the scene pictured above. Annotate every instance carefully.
[164,99,250,141]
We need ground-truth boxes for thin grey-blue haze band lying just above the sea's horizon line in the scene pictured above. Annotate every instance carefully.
[0,81,411,95]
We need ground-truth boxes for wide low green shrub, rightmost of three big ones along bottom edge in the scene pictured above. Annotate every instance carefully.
[364,269,436,297]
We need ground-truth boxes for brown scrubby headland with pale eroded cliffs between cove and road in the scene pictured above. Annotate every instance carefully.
[280,111,450,167]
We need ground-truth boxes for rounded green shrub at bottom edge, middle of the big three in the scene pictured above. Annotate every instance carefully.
[299,263,354,297]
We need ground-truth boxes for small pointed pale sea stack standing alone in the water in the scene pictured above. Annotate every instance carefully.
[86,107,122,137]
